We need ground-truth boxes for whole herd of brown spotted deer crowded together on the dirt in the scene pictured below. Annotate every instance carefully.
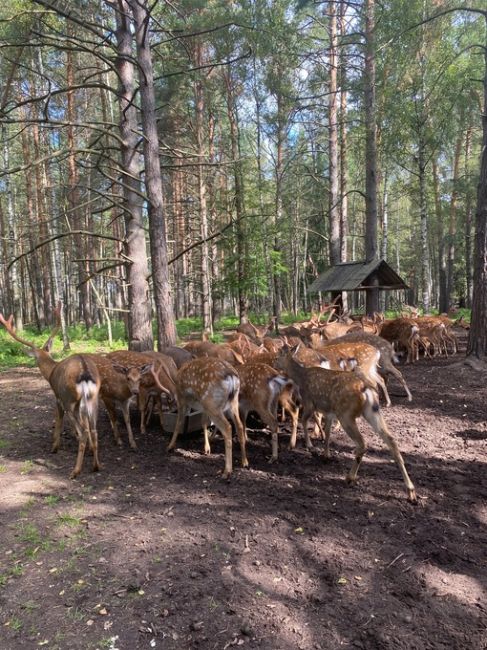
[0,305,463,503]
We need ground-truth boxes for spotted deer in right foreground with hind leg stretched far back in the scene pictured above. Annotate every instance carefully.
[276,348,416,503]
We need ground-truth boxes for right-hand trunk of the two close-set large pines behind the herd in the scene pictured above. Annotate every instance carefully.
[129,0,176,348]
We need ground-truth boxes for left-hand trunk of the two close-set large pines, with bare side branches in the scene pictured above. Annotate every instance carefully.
[116,0,154,352]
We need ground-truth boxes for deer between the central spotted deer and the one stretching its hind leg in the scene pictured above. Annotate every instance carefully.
[238,362,298,463]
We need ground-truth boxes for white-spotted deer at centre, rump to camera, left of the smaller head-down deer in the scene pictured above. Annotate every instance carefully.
[152,357,249,478]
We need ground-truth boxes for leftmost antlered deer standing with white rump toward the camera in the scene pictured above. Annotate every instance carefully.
[0,304,100,478]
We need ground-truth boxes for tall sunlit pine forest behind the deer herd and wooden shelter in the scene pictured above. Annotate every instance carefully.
[0,0,487,349]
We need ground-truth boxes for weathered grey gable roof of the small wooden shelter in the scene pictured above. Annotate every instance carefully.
[308,260,408,293]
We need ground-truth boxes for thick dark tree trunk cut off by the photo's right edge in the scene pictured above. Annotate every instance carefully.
[467,12,487,358]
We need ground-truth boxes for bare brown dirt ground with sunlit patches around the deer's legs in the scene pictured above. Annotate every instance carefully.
[0,332,487,650]
